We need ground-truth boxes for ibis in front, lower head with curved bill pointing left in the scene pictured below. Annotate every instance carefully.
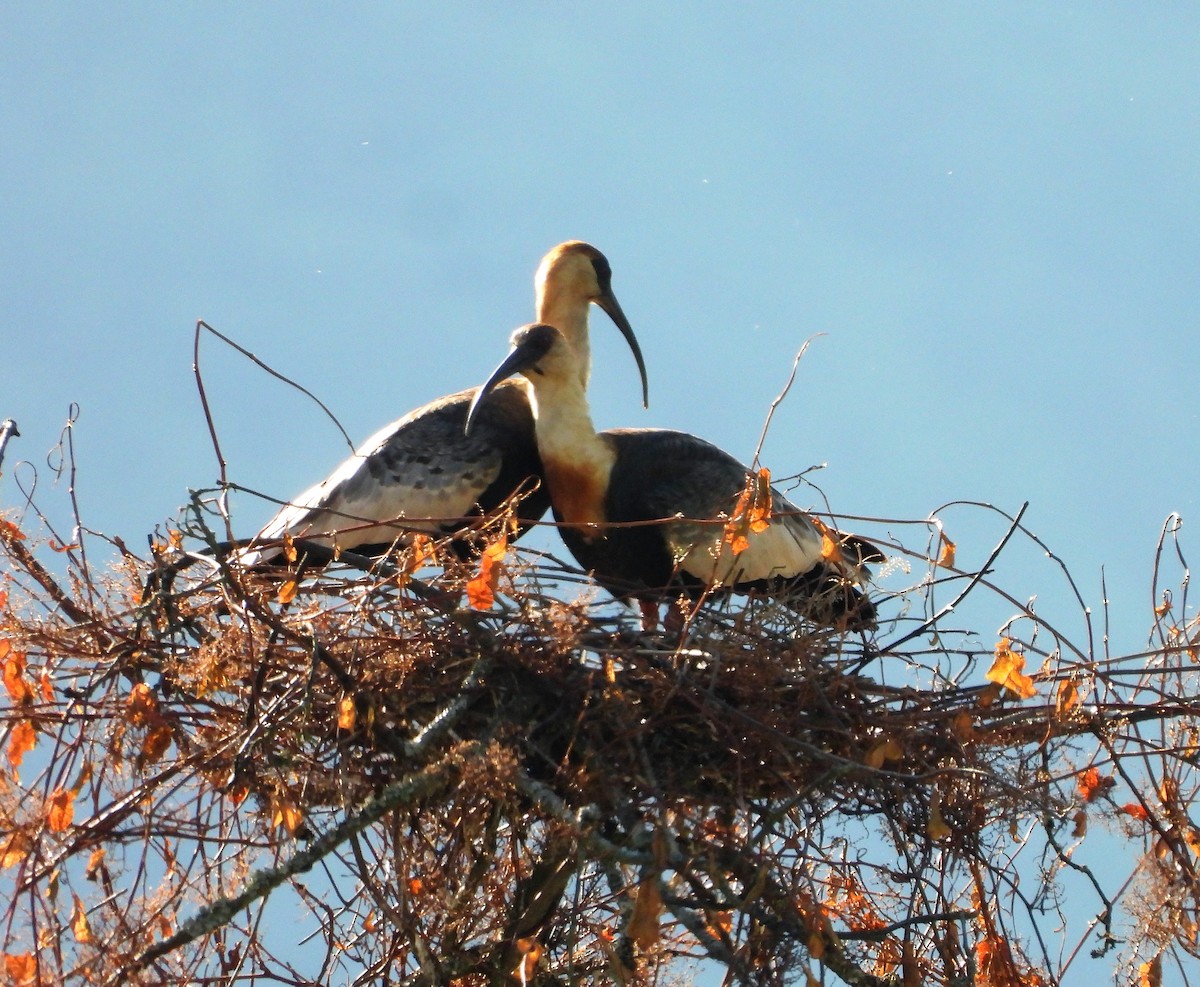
[466,324,883,628]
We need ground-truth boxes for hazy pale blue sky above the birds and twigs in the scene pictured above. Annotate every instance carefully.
[0,2,1200,984]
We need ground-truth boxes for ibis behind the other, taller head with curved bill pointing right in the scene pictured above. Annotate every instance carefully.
[240,240,649,564]
